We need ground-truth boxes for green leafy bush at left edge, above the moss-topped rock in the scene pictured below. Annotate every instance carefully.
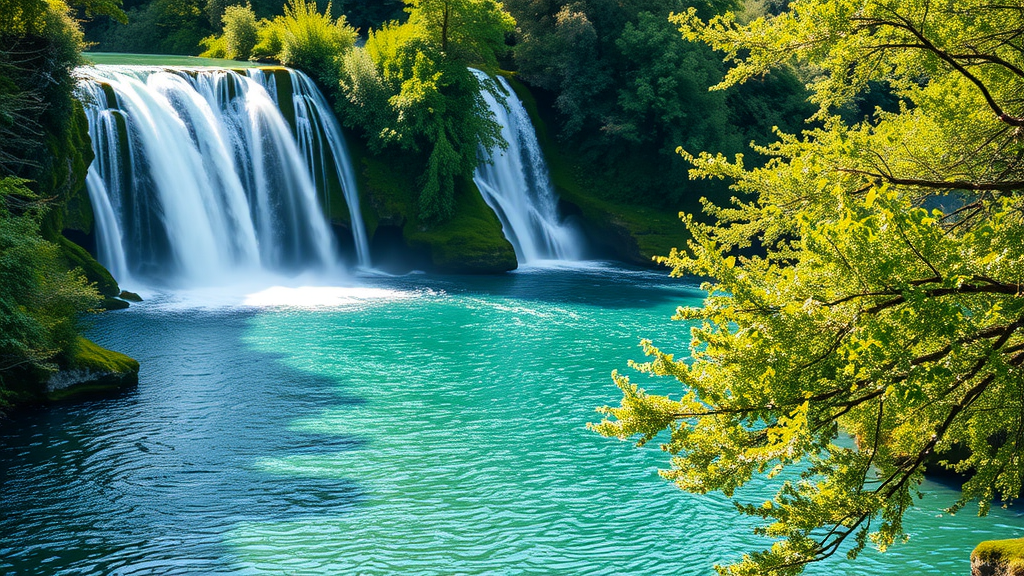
[0,177,98,384]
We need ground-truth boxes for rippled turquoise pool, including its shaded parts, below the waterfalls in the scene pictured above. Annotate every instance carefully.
[0,269,1024,575]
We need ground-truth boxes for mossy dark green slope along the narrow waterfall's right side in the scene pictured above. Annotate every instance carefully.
[503,73,689,265]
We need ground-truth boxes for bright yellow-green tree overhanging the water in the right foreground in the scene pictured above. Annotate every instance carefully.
[594,0,1024,574]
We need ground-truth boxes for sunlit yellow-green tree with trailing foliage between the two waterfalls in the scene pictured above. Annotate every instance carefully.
[341,0,514,223]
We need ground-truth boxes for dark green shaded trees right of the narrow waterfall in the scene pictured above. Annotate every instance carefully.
[499,0,812,212]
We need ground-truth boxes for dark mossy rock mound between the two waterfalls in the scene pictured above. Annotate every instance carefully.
[348,130,518,274]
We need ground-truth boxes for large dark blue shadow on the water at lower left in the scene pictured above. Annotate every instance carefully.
[0,308,366,574]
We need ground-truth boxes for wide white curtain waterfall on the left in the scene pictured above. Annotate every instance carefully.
[79,66,369,284]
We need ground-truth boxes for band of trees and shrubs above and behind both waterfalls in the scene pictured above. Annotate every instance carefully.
[79,0,812,223]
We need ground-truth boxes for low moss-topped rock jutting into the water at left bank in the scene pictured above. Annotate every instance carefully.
[45,336,139,402]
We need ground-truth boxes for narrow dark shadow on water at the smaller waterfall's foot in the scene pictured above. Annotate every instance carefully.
[384,262,706,310]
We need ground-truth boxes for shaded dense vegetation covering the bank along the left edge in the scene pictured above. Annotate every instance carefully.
[0,0,119,408]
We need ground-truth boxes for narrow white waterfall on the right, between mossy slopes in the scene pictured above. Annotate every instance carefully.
[472,70,583,263]
